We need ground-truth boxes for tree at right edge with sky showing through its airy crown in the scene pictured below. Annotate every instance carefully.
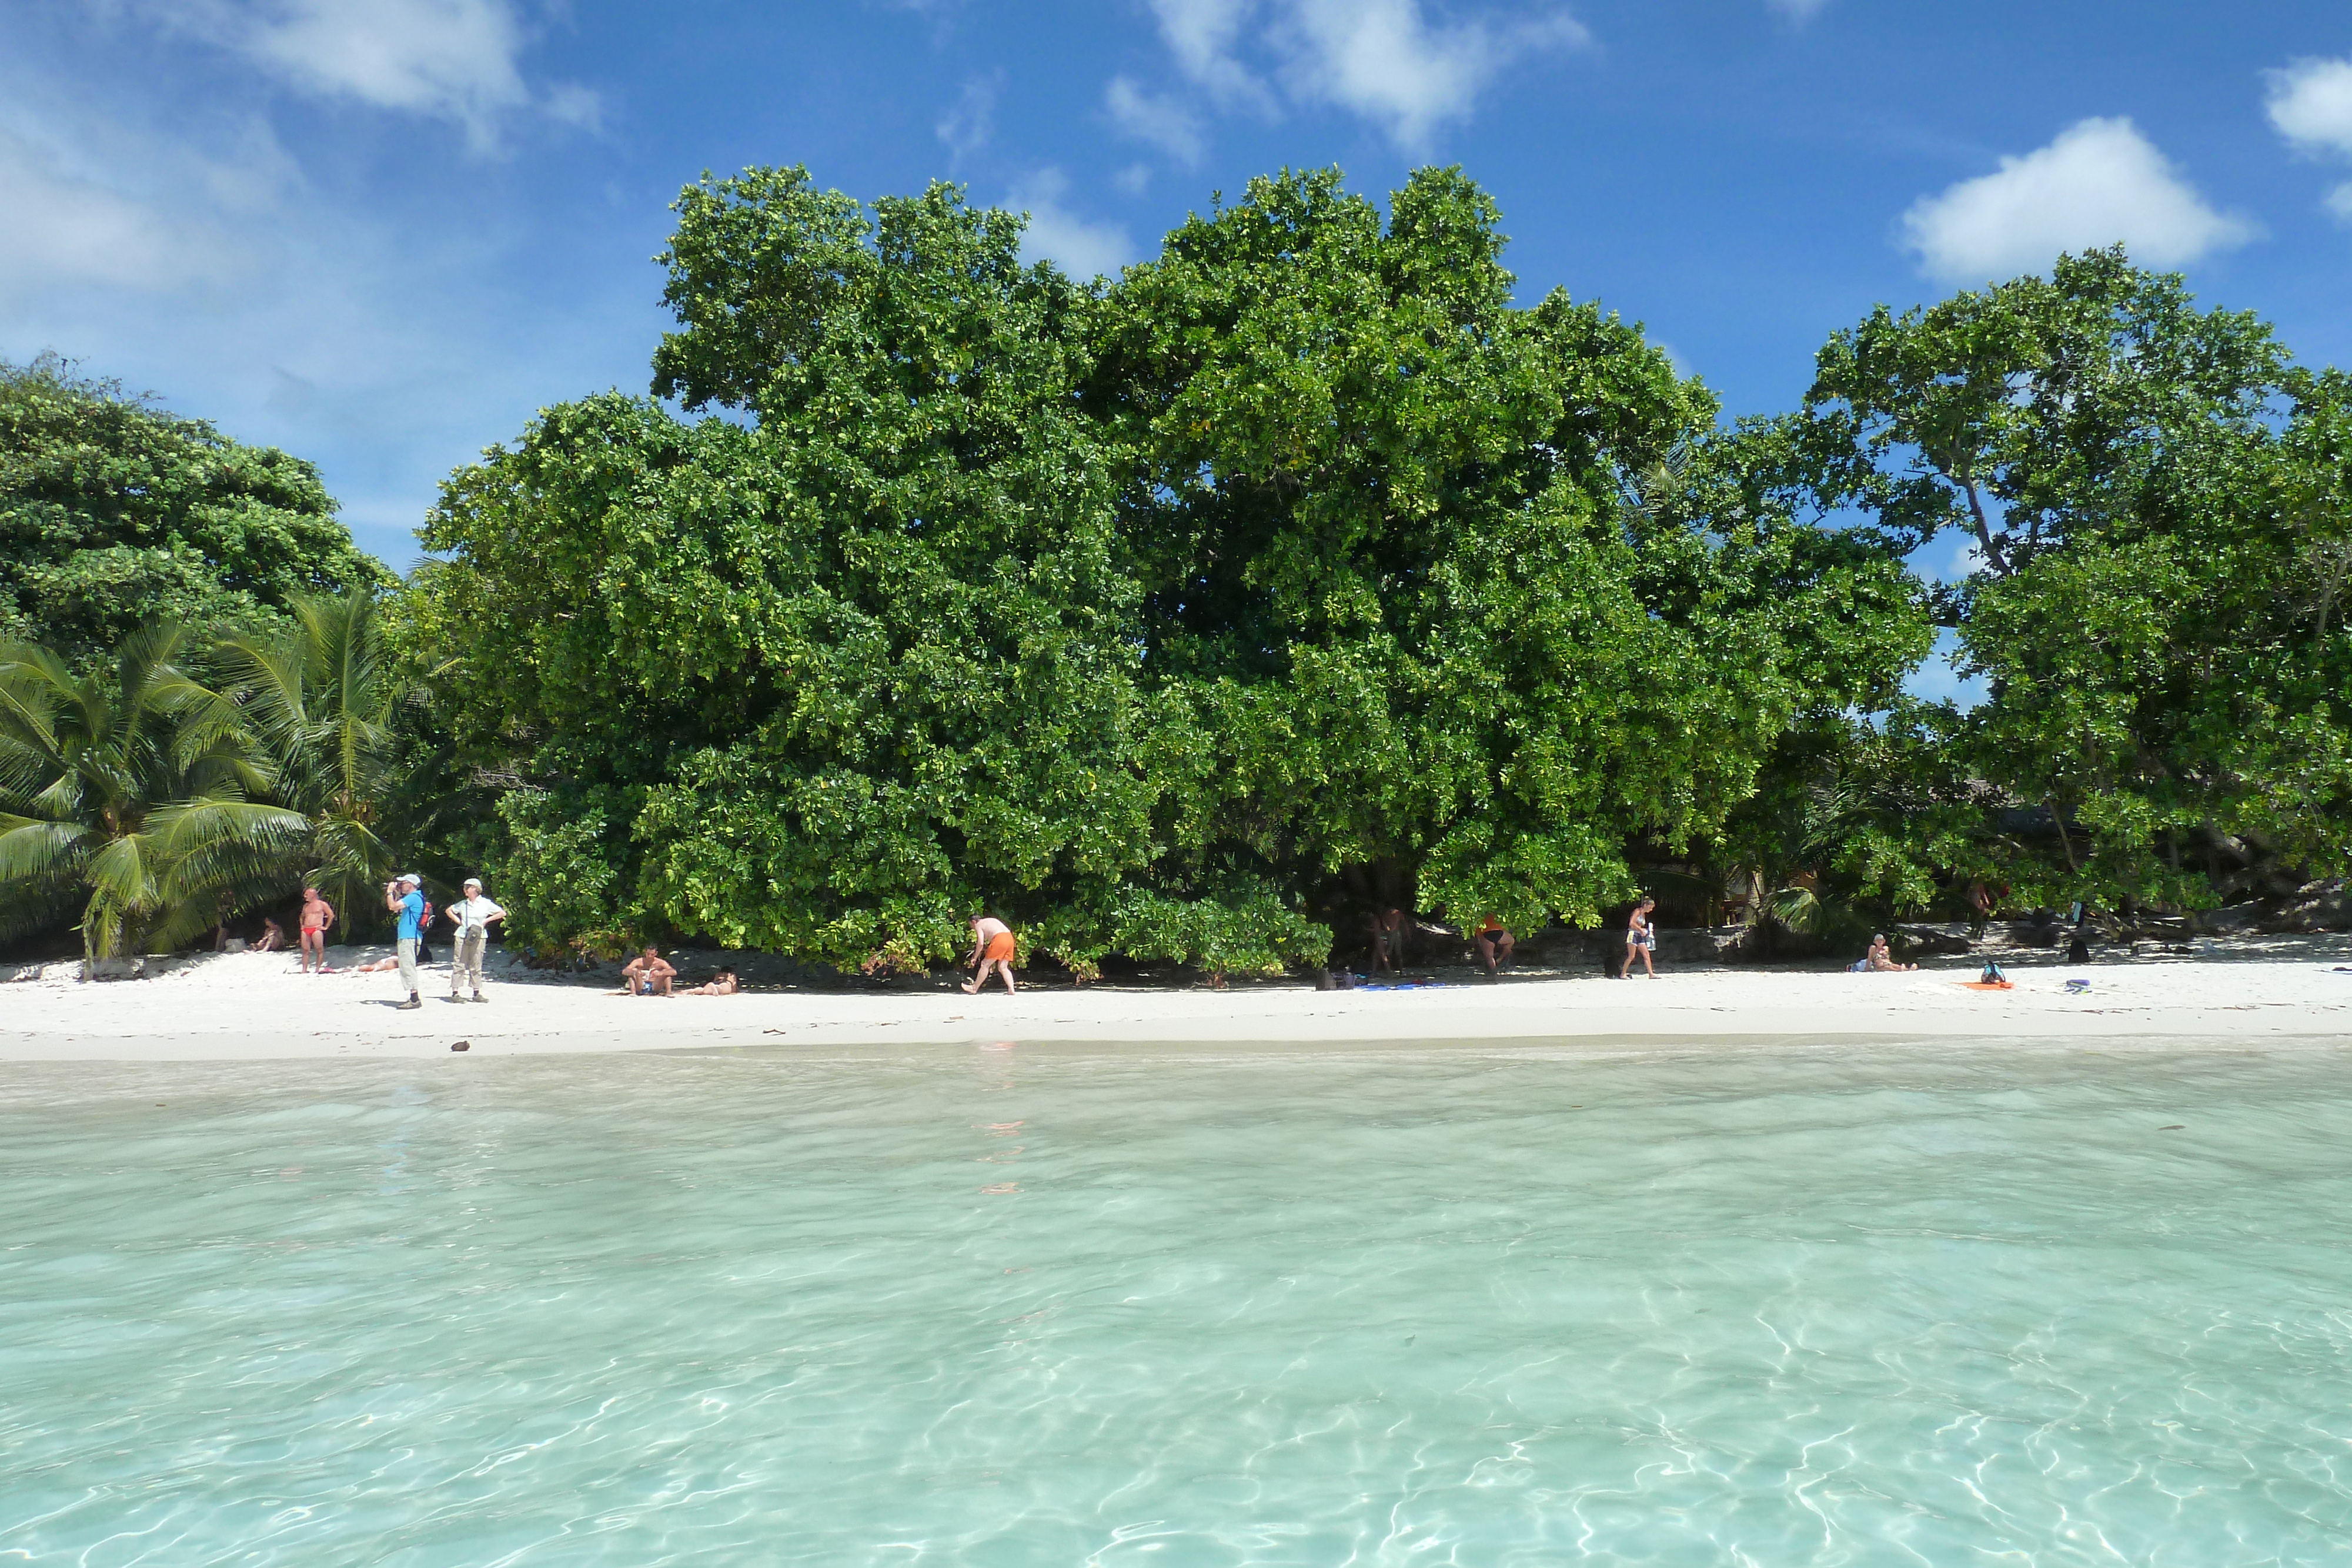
[1795,249,2352,910]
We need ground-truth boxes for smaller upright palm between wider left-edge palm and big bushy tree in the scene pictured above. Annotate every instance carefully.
[214,593,400,912]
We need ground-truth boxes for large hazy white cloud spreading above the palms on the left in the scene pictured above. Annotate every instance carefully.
[0,47,644,567]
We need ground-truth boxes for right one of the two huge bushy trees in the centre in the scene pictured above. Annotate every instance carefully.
[1087,169,1924,924]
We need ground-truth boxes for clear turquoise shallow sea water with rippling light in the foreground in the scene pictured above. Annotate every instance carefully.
[0,1046,2352,1568]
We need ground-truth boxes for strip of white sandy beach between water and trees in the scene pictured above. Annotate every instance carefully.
[0,935,2352,1060]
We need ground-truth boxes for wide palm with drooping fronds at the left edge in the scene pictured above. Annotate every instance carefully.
[0,623,306,980]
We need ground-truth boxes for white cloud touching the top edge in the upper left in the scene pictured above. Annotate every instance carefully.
[153,0,600,146]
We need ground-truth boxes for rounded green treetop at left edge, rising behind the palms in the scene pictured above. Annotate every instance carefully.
[0,357,390,668]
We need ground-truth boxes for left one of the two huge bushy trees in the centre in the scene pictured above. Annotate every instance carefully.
[416,169,1312,964]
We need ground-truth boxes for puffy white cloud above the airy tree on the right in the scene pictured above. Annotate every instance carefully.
[1903,118,2258,282]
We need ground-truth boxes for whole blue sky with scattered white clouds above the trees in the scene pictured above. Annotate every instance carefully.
[0,0,2352,592]
